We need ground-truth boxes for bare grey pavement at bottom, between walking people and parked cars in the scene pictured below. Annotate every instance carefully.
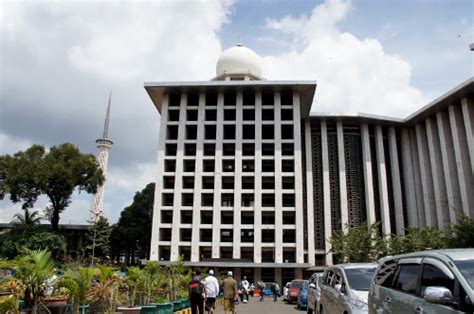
[214,298,306,314]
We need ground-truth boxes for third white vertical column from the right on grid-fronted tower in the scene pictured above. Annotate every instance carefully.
[253,92,262,262]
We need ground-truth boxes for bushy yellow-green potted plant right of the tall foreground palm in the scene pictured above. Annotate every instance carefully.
[59,267,95,314]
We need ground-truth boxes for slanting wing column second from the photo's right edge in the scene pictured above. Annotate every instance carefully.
[449,105,474,217]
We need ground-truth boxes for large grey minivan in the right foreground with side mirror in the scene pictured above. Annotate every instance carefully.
[369,249,474,314]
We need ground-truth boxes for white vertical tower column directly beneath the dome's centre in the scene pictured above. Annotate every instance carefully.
[233,91,243,259]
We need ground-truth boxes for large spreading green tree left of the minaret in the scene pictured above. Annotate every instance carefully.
[0,143,104,231]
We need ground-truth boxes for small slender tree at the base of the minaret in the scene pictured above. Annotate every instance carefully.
[86,216,112,258]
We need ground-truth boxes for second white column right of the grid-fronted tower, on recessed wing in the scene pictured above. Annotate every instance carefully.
[318,120,333,266]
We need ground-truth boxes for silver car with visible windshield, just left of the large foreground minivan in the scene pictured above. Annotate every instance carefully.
[319,263,377,314]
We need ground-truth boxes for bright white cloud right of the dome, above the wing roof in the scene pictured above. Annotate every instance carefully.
[264,0,427,117]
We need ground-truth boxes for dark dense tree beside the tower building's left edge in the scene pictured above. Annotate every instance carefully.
[110,183,155,264]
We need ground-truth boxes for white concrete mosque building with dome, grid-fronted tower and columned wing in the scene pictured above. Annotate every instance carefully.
[145,44,474,284]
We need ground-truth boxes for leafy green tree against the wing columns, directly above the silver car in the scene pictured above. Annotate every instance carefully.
[331,223,387,263]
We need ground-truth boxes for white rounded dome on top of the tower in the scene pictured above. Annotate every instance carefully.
[216,44,262,79]
